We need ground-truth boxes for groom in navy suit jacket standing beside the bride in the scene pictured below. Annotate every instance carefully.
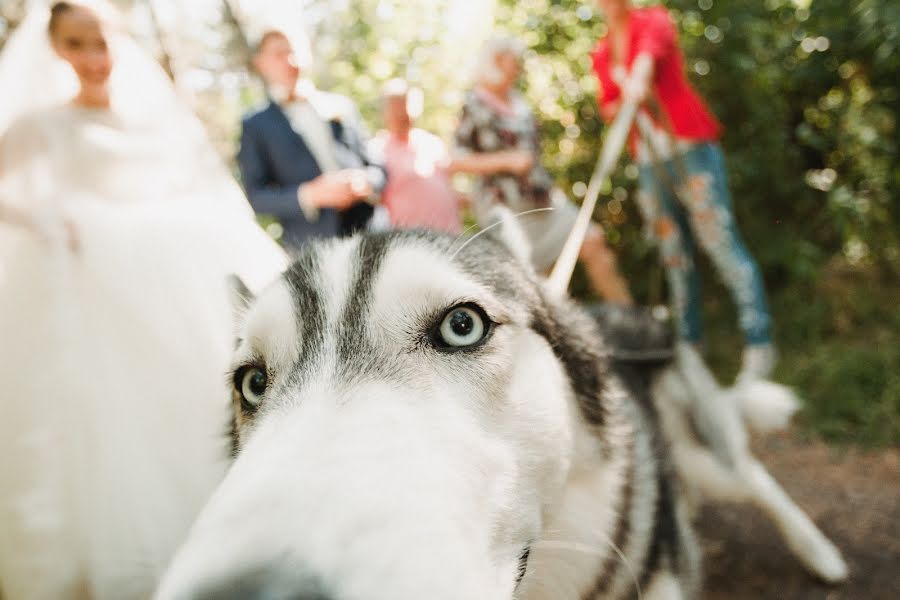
[237,30,385,249]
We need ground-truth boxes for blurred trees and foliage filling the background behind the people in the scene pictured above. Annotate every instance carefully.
[0,0,900,446]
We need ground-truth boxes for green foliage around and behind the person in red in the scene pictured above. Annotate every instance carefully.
[497,0,900,444]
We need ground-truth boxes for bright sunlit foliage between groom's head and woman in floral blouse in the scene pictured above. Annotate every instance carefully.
[308,0,491,137]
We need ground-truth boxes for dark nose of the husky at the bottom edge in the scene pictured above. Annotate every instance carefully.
[191,571,334,600]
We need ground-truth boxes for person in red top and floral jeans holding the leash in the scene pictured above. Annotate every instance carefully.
[593,0,775,380]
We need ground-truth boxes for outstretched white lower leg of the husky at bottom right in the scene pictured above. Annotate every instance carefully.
[737,454,849,583]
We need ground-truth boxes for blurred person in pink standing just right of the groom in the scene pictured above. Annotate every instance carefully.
[370,79,462,234]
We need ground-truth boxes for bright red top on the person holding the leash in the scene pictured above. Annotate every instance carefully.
[593,6,722,151]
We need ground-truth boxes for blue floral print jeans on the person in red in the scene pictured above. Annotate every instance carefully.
[638,143,771,344]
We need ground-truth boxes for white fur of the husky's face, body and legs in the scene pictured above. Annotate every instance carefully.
[158,226,846,600]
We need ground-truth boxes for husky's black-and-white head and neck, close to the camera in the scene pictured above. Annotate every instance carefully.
[158,225,844,600]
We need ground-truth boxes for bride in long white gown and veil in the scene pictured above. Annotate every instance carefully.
[0,0,285,600]
